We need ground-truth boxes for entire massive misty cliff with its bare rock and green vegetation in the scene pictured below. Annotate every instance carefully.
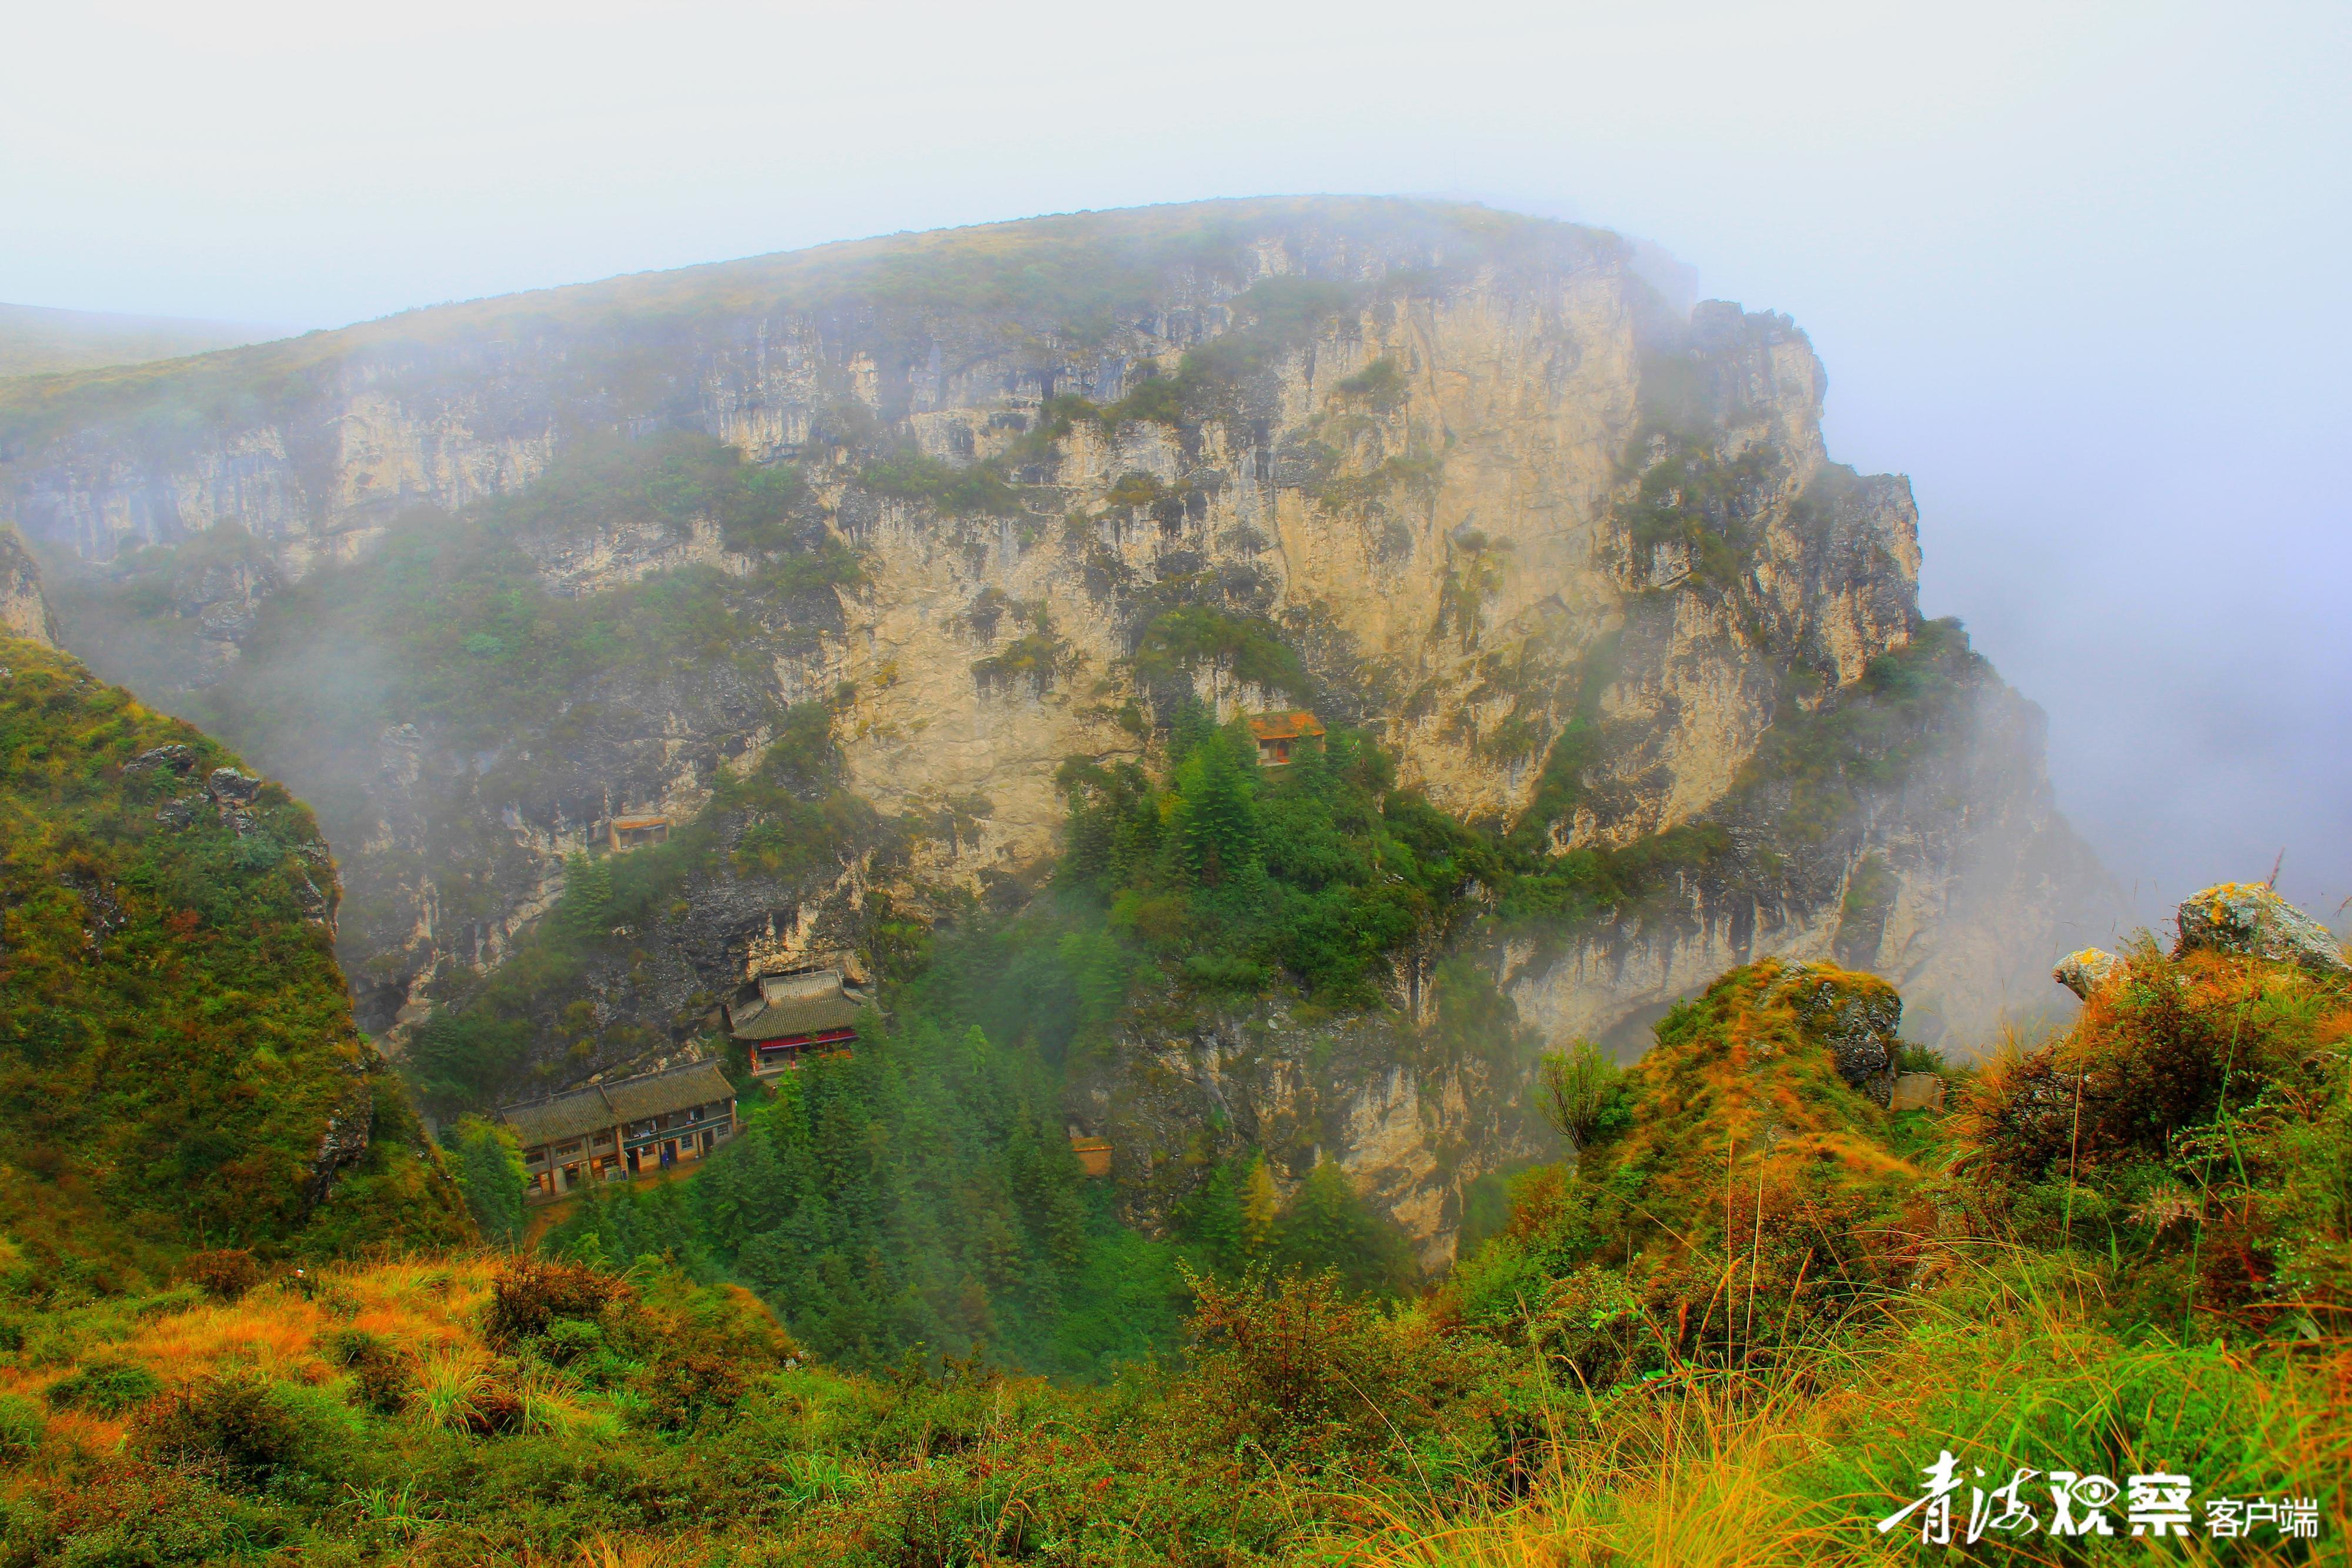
[0,200,2117,1269]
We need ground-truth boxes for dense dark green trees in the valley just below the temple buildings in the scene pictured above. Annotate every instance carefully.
[524,945,1416,1380]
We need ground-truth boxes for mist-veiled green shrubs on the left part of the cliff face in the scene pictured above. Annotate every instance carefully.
[54,435,858,978]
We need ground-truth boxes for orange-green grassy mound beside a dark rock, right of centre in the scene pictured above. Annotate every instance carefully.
[1449,959,1936,1382]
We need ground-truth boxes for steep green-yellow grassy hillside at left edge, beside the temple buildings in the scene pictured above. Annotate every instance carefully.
[0,640,466,1286]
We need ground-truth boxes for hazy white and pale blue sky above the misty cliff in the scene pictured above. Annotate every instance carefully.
[0,0,2352,912]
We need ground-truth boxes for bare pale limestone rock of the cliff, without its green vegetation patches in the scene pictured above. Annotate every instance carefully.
[0,202,2096,1251]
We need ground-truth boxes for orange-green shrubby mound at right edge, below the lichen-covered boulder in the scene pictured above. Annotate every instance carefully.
[1959,940,2352,1340]
